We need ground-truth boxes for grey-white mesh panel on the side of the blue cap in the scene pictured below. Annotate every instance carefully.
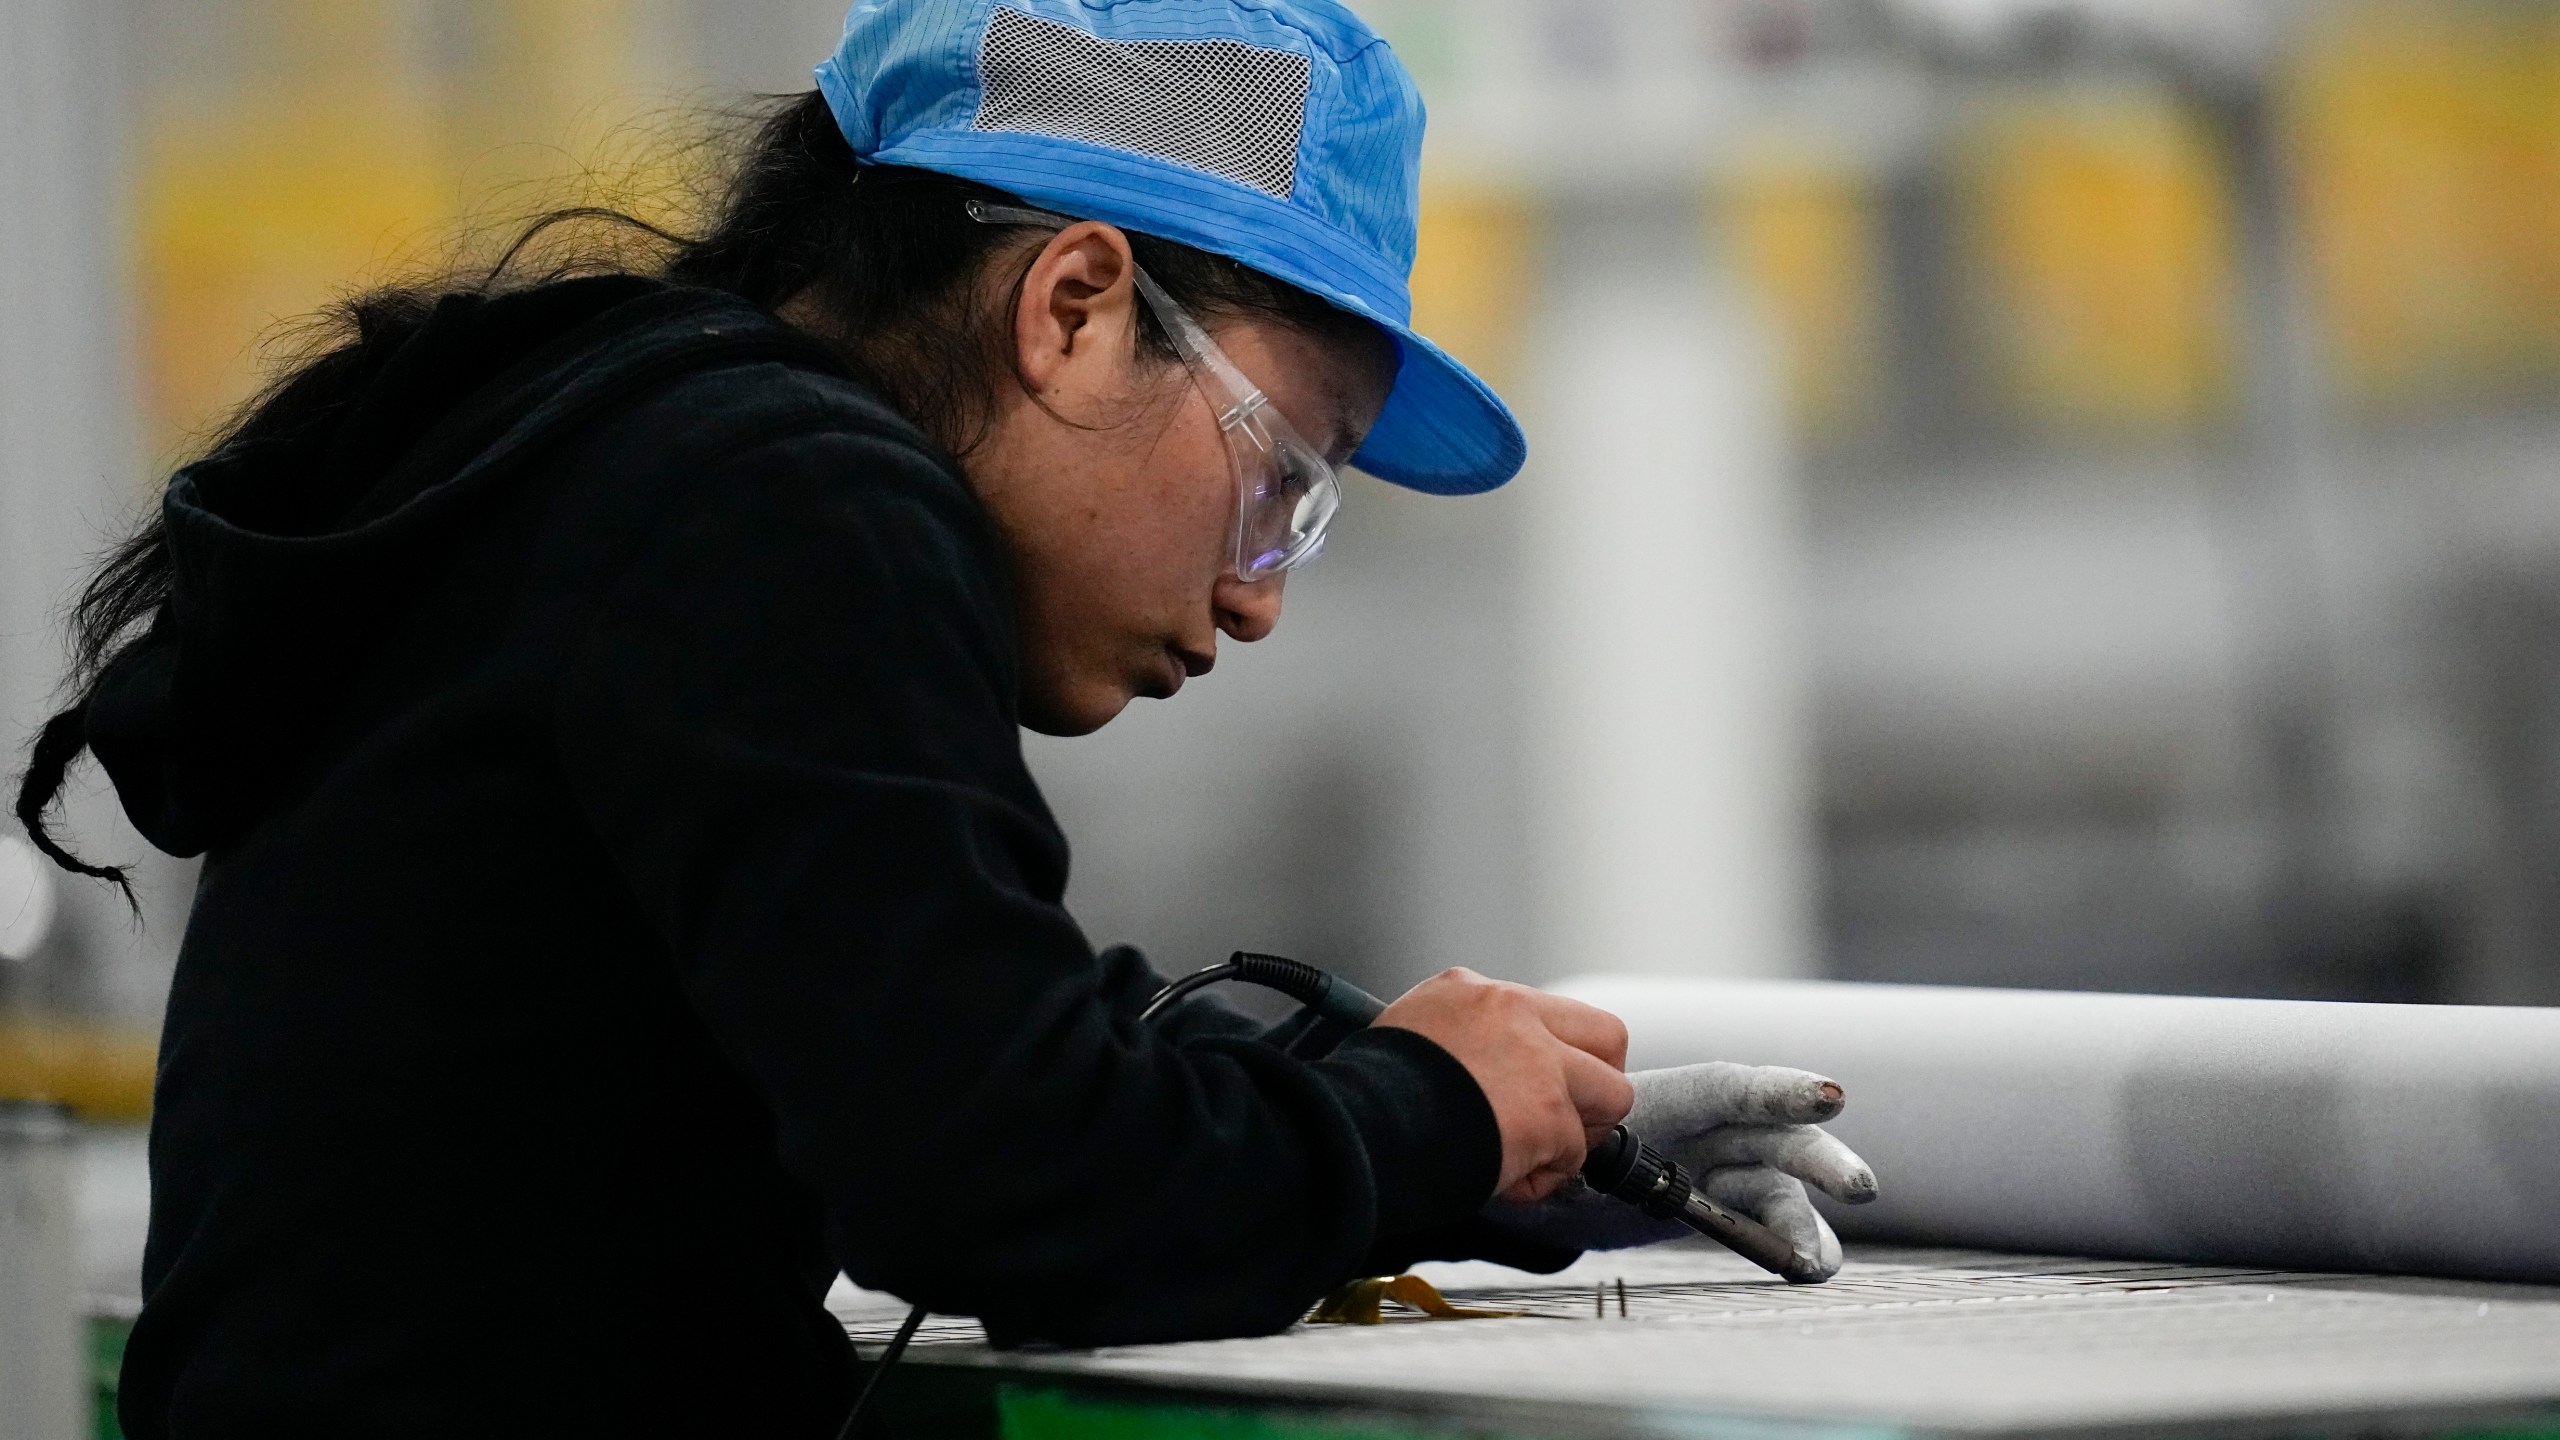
[975,8,1308,200]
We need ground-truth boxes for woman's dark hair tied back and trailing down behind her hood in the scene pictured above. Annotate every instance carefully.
[15,90,1380,902]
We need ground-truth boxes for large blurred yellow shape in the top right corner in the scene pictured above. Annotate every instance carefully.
[2284,0,2560,407]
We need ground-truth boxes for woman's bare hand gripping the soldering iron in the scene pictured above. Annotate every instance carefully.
[1377,969,1633,1204]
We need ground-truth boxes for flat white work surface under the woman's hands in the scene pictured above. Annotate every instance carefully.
[837,1243,2560,1435]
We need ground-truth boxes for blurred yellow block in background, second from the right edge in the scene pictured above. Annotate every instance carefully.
[1958,90,2232,433]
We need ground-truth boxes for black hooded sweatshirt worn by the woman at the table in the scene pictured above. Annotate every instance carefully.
[87,279,1556,1440]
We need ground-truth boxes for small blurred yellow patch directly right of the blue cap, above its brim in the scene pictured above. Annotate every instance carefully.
[1413,187,1539,389]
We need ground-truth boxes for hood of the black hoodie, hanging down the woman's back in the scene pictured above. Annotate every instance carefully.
[84,277,814,856]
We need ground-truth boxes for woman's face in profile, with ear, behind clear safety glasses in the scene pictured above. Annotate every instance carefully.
[963,223,1395,735]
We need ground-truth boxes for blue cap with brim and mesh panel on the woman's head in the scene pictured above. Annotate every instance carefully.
[817,0,1528,495]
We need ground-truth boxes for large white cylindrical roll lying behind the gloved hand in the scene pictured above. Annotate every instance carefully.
[1556,976,2560,1281]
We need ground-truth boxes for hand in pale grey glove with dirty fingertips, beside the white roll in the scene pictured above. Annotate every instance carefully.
[1485,1061,1876,1279]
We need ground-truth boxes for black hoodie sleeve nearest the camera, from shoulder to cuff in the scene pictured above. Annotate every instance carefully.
[553,430,1500,1345]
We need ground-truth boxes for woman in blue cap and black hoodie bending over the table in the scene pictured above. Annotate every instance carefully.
[18,0,1856,1440]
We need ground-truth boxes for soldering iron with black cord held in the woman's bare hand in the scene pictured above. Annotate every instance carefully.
[1139,951,1823,1284]
